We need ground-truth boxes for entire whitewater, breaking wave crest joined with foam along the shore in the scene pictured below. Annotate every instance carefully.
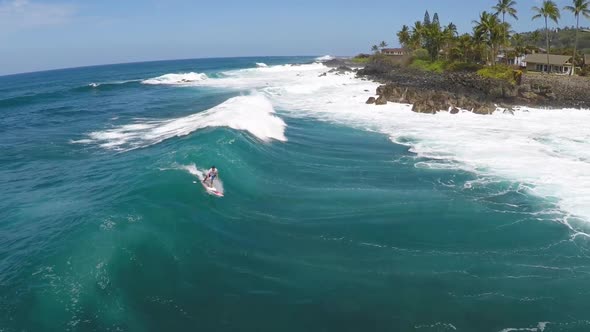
[98,62,590,224]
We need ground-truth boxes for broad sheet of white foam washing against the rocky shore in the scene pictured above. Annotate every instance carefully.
[187,63,590,220]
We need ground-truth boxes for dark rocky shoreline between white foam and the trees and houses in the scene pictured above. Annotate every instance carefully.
[324,59,590,114]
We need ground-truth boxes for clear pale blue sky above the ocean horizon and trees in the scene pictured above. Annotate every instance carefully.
[0,0,590,75]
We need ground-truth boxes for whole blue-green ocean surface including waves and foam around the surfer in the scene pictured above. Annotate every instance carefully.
[0,57,590,332]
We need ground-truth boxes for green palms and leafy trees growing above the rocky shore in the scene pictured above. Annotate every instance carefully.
[354,0,590,81]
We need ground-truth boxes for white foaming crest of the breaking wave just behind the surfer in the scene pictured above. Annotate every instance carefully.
[83,94,287,151]
